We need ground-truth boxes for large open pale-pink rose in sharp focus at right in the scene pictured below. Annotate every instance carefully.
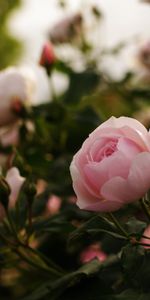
[70,117,150,212]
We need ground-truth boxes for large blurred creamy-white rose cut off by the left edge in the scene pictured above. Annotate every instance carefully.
[0,67,36,126]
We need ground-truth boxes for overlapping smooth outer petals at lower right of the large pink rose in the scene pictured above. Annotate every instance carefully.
[101,152,150,203]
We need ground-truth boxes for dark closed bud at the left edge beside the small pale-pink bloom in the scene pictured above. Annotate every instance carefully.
[0,176,11,209]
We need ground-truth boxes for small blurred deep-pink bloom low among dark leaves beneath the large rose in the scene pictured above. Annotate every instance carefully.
[80,244,107,263]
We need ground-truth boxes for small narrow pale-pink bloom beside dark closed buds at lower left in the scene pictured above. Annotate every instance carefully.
[5,167,25,207]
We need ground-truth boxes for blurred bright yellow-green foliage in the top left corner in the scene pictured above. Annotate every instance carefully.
[0,0,21,69]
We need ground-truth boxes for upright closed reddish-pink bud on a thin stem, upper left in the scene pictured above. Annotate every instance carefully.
[39,42,56,69]
